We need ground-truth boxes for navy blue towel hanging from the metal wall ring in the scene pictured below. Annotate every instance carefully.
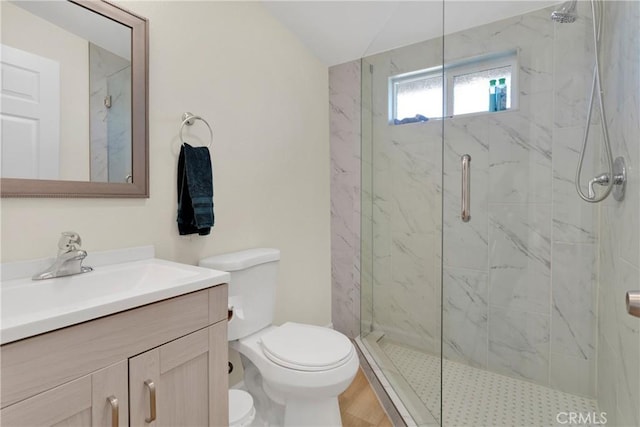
[178,143,214,236]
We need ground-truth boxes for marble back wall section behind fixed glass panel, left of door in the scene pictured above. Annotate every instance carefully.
[363,40,442,354]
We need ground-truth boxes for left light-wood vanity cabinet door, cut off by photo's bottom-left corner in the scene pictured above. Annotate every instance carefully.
[0,361,129,427]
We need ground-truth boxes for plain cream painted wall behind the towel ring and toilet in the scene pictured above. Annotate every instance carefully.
[2,1,331,325]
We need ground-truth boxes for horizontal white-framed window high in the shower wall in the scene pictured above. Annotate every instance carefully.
[389,51,518,124]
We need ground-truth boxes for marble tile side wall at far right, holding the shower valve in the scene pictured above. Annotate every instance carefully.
[597,1,640,426]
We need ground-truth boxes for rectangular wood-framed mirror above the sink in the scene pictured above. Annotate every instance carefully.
[0,0,149,197]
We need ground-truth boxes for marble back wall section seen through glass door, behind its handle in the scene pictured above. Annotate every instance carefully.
[443,3,600,397]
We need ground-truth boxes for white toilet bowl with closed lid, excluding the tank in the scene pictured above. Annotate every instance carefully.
[229,322,359,426]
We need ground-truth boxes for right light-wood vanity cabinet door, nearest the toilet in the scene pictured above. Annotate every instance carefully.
[129,321,228,427]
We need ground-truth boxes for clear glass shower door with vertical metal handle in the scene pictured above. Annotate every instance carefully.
[441,1,640,426]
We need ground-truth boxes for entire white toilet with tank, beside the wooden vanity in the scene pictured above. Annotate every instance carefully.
[199,248,359,427]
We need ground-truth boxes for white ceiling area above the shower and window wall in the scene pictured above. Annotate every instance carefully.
[263,0,558,66]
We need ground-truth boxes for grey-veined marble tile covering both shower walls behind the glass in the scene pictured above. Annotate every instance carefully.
[332,1,640,412]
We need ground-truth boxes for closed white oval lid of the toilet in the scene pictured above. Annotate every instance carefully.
[262,322,354,371]
